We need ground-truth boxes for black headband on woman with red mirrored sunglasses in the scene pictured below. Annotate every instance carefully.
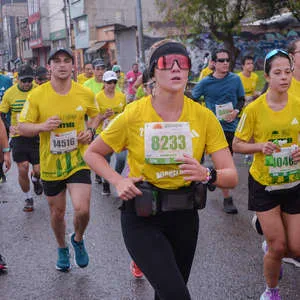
[149,42,190,78]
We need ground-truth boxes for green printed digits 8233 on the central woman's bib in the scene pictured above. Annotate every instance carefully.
[151,135,186,151]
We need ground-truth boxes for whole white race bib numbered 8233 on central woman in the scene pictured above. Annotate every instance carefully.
[144,122,193,165]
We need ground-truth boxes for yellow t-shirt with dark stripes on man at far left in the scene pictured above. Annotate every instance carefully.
[0,84,35,133]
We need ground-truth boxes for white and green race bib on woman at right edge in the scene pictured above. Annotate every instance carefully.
[265,146,300,177]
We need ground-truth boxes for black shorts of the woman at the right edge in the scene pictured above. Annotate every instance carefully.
[248,173,300,214]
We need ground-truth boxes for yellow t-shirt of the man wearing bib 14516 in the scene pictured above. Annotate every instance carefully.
[20,81,99,181]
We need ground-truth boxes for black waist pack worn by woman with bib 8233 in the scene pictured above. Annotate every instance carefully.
[134,181,207,217]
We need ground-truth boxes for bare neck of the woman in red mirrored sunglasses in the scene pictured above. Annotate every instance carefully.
[152,88,184,122]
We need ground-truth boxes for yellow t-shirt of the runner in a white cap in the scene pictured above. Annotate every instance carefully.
[96,90,126,134]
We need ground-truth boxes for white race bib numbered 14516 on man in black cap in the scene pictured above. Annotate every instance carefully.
[50,130,78,154]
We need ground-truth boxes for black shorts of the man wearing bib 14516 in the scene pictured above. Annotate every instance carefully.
[42,169,92,197]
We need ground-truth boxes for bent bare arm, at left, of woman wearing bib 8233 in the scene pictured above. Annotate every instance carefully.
[84,136,142,200]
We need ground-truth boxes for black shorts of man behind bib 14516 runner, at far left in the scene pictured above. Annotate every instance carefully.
[10,136,40,165]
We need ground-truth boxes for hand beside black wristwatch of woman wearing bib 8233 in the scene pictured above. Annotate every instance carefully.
[177,154,207,181]
